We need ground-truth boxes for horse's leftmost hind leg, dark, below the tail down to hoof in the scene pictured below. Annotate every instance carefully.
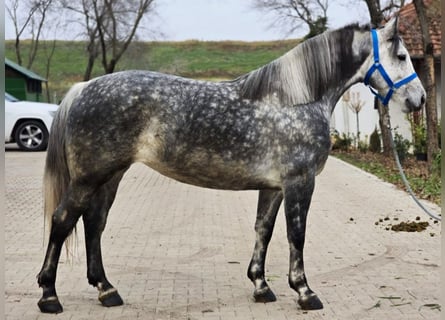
[37,182,94,313]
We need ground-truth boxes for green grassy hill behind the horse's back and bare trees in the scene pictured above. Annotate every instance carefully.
[5,40,299,99]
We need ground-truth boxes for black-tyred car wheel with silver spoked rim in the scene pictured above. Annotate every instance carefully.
[14,120,49,151]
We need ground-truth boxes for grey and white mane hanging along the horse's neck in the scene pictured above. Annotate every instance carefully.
[237,24,370,105]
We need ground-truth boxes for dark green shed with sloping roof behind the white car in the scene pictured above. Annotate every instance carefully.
[5,58,47,101]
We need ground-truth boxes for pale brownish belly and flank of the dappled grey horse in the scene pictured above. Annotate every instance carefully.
[134,123,281,190]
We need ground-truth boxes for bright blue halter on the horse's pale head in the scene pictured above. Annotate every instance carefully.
[364,29,417,106]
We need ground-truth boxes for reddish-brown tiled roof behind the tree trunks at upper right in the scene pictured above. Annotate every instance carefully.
[399,0,441,58]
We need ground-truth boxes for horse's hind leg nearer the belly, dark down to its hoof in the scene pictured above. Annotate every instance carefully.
[82,169,126,307]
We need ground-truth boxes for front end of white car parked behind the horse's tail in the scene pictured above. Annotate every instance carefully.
[5,92,59,151]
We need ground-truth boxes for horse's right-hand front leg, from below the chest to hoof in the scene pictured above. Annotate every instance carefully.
[284,172,323,310]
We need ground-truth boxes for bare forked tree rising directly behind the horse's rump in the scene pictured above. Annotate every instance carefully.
[62,0,154,80]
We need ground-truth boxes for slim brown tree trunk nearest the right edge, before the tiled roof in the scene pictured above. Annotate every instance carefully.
[413,0,440,172]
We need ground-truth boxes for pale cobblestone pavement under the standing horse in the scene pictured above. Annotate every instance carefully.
[5,150,440,320]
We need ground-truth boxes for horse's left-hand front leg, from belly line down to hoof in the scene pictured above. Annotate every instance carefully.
[247,190,283,302]
